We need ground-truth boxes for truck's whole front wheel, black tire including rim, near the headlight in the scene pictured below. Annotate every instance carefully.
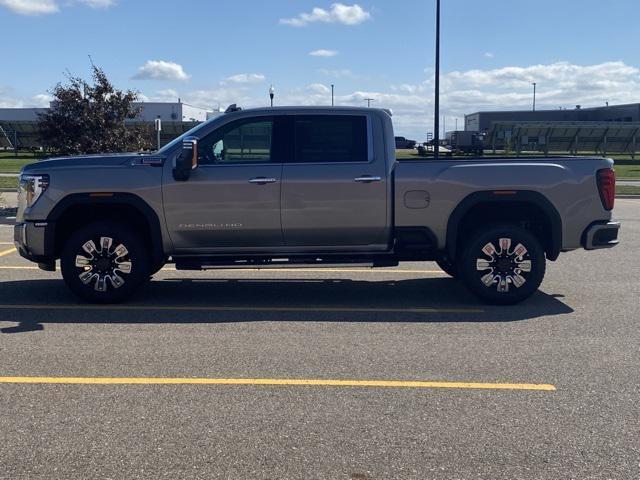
[60,221,151,303]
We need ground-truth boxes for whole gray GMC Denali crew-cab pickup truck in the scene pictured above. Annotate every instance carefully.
[14,107,620,304]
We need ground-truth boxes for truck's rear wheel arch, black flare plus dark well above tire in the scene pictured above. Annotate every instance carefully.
[446,190,562,260]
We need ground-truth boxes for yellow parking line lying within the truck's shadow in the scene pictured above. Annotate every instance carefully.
[0,304,484,313]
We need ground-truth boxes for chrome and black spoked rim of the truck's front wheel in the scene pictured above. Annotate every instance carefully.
[75,237,133,292]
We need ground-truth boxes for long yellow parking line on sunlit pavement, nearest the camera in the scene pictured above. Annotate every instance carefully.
[0,377,556,392]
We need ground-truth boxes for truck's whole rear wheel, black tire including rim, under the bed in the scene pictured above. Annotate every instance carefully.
[459,224,546,305]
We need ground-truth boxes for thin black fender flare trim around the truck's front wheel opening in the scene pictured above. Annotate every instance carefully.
[45,192,165,264]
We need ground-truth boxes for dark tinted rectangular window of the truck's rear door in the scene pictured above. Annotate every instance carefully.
[294,115,368,163]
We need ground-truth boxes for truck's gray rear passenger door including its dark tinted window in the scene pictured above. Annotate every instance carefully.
[281,114,389,250]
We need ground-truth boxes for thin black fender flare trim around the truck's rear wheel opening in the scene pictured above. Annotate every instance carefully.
[446,190,562,260]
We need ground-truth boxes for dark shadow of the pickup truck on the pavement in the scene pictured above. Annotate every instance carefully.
[0,278,573,333]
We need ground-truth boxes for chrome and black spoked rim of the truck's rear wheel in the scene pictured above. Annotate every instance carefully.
[476,237,532,294]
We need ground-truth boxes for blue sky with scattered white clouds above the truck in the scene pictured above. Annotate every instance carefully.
[0,0,640,139]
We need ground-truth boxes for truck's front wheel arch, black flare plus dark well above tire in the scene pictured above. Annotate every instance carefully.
[46,193,166,266]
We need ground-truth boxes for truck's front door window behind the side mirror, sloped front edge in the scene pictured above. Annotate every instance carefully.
[198,119,273,165]
